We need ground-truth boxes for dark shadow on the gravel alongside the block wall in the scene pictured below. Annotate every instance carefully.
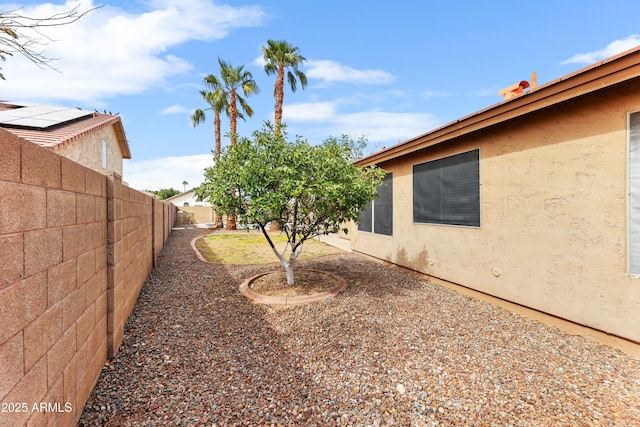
[79,230,352,426]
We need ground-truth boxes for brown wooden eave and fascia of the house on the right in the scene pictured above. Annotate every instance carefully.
[354,46,640,166]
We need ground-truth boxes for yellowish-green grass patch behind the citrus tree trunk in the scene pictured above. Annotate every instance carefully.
[196,233,344,264]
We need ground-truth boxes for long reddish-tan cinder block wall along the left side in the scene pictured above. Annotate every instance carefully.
[0,129,175,427]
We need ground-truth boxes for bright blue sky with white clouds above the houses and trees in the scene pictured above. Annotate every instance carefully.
[0,0,640,190]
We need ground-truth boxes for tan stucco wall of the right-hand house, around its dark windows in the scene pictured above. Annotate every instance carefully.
[349,84,640,342]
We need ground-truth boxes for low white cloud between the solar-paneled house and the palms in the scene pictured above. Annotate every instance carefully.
[122,154,213,191]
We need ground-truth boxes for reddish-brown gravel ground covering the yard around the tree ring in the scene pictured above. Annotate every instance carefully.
[80,230,640,427]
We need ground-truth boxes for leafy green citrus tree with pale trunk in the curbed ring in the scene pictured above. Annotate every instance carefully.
[197,123,385,285]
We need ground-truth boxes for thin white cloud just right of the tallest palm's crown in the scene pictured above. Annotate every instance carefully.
[304,60,395,84]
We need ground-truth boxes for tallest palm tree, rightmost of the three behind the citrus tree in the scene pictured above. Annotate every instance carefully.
[262,40,307,134]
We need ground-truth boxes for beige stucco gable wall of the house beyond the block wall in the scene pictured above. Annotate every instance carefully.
[55,126,122,176]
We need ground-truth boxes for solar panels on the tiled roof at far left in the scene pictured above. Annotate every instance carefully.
[0,103,93,129]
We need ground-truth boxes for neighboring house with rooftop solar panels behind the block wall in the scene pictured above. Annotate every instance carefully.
[0,101,131,176]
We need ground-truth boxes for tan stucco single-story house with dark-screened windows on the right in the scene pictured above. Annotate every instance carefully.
[349,48,640,343]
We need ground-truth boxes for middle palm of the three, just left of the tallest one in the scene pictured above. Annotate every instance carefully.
[218,58,259,145]
